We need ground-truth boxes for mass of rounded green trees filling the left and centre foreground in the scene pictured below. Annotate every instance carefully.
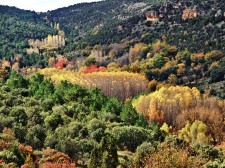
[0,73,154,167]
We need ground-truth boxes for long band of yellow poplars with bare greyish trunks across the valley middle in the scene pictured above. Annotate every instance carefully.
[40,66,148,100]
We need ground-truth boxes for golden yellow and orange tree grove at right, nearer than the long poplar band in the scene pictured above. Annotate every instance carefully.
[133,86,225,143]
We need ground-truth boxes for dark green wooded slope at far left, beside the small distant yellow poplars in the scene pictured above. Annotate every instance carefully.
[0,5,55,58]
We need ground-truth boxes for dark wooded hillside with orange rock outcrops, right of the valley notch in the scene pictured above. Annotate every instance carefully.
[44,0,225,51]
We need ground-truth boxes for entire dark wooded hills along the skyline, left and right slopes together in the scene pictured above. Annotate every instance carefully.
[0,0,225,59]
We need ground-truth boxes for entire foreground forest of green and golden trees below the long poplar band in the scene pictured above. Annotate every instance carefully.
[0,71,225,168]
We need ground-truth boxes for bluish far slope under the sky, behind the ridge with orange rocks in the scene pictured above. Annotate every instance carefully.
[44,0,165,39]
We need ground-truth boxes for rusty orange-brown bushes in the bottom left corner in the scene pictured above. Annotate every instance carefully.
[0,128,76,168]
